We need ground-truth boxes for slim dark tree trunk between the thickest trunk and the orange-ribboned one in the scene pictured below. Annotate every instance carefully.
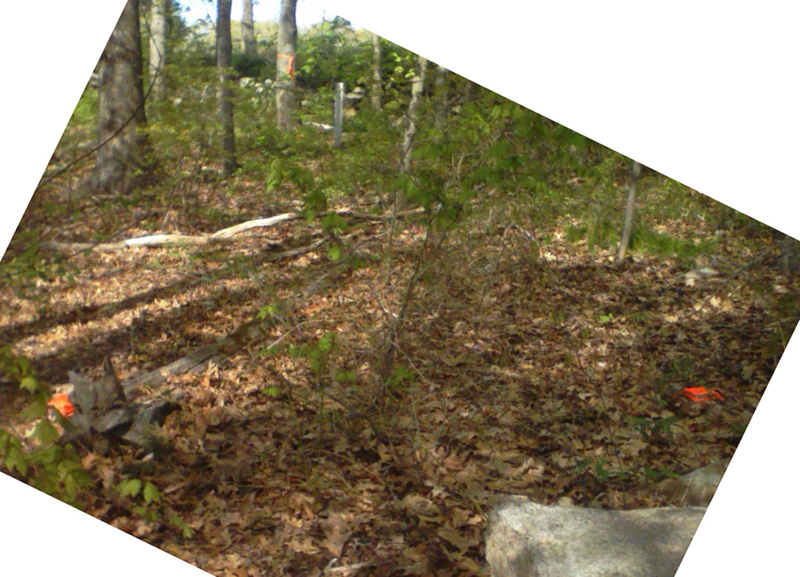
[217,0,237,176]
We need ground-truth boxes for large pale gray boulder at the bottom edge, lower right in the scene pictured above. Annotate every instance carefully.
[486,497,706,577]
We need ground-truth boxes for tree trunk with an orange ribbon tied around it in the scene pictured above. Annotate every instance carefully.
[275,0,297,132]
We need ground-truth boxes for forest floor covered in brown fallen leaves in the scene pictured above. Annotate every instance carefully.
[0,163,800,577]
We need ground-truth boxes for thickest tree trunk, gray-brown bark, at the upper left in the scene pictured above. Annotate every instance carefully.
[93,0,154,194]
